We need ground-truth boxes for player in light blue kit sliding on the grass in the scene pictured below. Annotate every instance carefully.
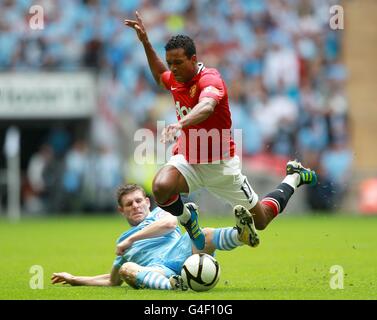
[51,184,256,290]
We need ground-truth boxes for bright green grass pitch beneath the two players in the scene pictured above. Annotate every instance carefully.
[0,213,377,300]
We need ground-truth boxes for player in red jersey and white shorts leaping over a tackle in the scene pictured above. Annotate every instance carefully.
[124,12,317,250]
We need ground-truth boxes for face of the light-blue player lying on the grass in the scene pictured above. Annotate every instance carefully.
[118,190,150,226]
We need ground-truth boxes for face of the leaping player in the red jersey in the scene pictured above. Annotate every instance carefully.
[166,48,197,82]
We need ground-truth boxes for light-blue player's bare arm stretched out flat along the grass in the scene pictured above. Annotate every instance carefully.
[51,267,122,287]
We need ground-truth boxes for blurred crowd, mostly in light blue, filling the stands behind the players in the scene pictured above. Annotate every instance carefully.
[0,0,352,214]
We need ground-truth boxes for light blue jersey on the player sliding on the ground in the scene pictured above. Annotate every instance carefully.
[113,207,181,268]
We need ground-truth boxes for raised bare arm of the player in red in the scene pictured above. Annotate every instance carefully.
[124,11,167,88]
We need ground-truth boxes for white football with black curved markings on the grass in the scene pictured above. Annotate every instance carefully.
[181,253,220,291]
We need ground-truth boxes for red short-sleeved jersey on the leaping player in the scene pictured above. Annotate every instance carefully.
[161,64,235,164]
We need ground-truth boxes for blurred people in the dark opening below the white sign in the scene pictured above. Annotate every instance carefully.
[23,131,123,213]
